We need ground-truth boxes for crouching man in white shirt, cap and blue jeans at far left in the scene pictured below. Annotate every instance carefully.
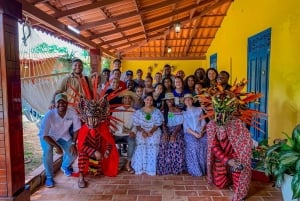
[39,93,81,188]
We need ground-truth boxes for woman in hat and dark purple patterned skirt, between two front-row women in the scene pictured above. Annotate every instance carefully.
[157,93,185,175]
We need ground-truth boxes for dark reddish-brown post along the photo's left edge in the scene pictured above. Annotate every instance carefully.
[0,0,30,201]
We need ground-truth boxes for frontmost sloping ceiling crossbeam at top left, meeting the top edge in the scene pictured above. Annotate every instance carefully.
[53,0,120,19]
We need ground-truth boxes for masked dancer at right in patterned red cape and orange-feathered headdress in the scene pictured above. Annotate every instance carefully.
[200,80,262,201]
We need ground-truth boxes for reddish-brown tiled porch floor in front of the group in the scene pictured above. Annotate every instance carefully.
[31,171,282,201]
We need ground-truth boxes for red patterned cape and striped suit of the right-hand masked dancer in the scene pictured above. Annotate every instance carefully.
[206,119,252,201]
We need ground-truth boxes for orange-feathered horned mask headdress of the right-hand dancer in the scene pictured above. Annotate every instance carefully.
[196,79,267,131]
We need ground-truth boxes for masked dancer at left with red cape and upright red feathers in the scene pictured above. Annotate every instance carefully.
[68,76,119,188]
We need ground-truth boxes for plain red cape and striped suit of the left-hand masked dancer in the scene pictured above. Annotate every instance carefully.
[78,122,119,177]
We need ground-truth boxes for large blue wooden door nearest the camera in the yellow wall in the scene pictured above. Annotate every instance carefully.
[247,28,271,142]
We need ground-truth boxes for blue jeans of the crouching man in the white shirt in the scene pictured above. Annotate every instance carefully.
[40,137,77,179]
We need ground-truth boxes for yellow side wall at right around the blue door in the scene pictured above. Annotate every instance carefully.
[207,0,300,140]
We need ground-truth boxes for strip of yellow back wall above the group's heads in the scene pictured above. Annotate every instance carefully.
[122,60,207,77]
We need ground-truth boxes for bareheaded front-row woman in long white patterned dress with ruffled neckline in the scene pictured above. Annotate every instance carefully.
[132,94,163,175]
